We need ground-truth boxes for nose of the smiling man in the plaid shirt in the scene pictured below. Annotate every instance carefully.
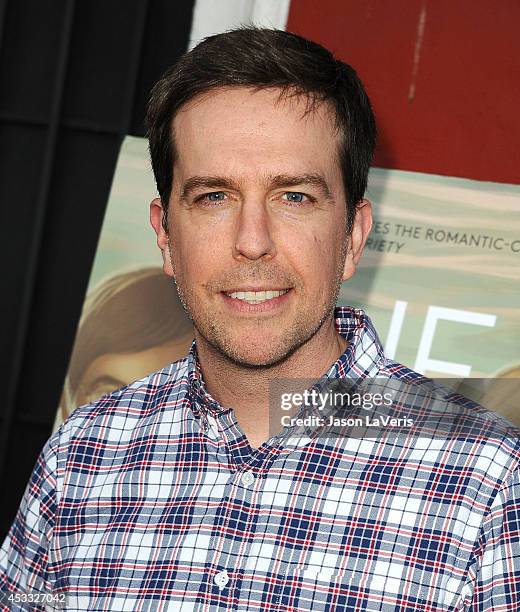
[233,198,276,261]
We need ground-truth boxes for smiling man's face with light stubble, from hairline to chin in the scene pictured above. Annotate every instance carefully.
[152,88,370,366]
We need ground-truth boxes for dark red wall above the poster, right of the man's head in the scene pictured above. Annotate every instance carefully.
[287,0,520,183]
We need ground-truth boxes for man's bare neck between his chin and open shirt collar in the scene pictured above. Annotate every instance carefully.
[195,314,348,447]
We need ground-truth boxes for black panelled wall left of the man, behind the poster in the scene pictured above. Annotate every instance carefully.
[0,0,193,540]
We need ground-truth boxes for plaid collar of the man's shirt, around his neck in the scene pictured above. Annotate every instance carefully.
[188,306,385,417]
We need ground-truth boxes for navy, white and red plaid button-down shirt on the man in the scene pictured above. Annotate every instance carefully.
[0,307,520,612]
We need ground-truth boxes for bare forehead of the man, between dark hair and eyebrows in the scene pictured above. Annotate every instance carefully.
[171,87,341,179]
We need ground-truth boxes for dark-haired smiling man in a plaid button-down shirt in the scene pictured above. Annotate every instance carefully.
[0,28,520,611]
